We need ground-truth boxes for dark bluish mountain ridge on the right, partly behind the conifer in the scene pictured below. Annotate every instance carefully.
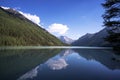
[72,28,111,46]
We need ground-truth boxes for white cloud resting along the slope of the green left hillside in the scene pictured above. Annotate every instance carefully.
[19,11,40,26]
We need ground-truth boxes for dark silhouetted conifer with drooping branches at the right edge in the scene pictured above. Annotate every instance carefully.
[102,0,120,50]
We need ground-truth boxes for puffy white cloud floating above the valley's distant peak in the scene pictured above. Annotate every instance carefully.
[47,23,69,35]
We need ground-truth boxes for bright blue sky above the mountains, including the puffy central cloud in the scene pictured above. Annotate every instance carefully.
[0,0,104,39]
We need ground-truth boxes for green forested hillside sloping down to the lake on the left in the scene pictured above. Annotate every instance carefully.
[0,8,64,46]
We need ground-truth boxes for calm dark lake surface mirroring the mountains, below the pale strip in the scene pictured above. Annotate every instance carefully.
[0,48,120,80]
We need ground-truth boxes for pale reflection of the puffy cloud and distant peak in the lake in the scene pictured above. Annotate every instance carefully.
[46,49,72,70]
